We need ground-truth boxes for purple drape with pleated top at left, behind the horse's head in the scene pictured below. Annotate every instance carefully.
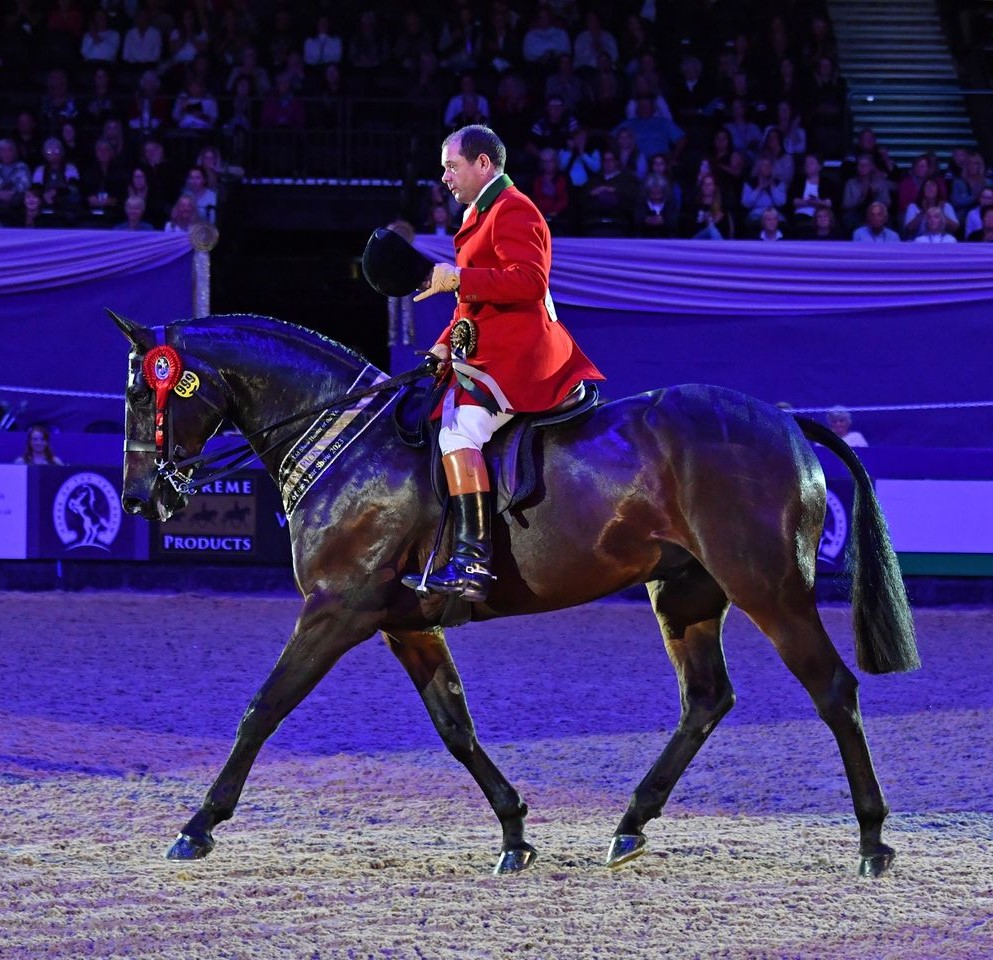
[0,230,193,431]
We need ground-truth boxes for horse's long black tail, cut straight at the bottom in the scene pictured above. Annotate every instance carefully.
[794,415,921,673]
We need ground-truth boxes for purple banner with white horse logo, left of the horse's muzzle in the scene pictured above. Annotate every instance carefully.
[28,467,148,560]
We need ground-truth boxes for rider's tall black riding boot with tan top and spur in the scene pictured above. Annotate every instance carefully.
[403,449,496,603]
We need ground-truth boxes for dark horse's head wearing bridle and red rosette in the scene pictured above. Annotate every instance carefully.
[107,310,226,520]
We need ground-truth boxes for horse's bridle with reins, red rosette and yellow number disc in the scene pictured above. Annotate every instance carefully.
[124,326,440,496]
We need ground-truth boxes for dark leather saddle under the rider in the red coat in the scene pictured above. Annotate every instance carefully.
[393,383,600,526]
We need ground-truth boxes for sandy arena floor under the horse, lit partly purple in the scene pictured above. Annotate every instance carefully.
[0,593,993,960]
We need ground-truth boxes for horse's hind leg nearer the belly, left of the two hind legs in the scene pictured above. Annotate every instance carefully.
[607,565,734,867]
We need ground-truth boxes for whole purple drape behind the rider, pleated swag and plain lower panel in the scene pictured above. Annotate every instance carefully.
[402,236,993,447]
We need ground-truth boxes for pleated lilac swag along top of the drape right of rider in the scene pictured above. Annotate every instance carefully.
[415,236,993,316]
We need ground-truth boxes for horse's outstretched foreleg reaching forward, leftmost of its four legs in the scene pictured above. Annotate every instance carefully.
[166,596,375,860]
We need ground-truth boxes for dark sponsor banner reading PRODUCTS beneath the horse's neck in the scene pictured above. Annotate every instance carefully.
[150,470,290,565]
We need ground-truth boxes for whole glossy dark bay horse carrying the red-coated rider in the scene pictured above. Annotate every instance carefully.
[114,316,919,876]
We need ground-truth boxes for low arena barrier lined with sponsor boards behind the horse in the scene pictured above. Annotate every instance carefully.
[0,446,993,577]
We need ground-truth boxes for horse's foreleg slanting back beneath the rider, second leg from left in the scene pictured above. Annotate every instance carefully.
[386,629,536,874]
